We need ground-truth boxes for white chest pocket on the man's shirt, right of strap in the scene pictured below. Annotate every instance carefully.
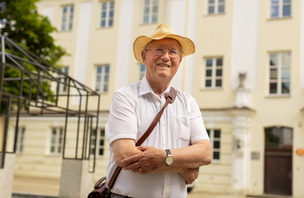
[173,117,190,144]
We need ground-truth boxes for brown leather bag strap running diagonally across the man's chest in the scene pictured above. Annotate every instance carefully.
[109,87,177,189]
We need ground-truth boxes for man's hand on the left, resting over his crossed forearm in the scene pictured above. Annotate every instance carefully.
[123,146,166,174]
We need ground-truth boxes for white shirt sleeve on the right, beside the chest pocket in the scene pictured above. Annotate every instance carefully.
[190,99,209,144]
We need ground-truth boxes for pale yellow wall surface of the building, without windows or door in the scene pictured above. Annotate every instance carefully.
[0,0,304,197]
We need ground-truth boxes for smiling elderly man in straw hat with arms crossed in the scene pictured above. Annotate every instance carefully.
[106,24,212,198]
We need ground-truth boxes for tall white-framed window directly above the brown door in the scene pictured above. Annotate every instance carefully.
[269,52,291,95]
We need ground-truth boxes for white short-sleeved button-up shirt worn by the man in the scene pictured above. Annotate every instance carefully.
[105,77,209,198]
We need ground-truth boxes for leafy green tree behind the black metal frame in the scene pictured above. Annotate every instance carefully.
[0,0,67,111]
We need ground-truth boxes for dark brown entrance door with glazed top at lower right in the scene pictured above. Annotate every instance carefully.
[264,127,293,195]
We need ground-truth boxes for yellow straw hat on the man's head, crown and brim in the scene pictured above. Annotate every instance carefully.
[133,23,195,63]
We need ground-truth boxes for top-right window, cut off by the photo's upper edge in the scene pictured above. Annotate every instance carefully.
[270,0,291,18]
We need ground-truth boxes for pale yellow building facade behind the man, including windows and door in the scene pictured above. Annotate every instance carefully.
[4,0,304,197]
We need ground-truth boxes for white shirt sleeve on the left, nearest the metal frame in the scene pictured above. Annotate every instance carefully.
[105,91,137,146]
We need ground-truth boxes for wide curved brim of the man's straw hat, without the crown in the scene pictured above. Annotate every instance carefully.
[133,34,195,63]
